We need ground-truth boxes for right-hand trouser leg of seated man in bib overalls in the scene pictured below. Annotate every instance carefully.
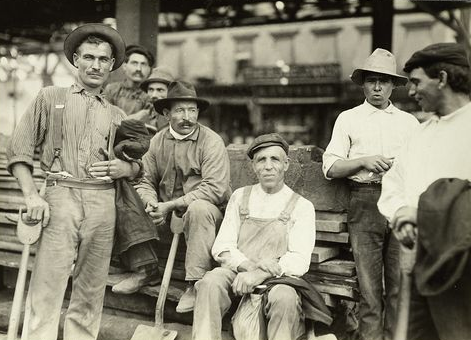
[265,284,305,340]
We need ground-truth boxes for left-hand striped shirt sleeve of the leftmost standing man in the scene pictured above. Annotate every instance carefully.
[7,89,49,173]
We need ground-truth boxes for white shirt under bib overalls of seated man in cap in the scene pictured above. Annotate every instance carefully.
[212,184,316,276]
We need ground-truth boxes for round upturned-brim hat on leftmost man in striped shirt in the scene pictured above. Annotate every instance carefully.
[64,24,126,71]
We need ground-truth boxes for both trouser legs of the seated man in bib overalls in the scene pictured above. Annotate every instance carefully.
[192,267,305,340]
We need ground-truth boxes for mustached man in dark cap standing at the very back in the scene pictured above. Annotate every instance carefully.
[104,45,155,124]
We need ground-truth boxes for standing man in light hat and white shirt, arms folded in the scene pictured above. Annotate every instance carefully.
[322,49,419,340]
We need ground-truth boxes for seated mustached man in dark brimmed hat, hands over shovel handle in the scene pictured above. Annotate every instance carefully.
[136,81,231,313]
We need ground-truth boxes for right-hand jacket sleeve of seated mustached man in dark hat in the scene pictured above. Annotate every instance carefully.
[176,136,230,208]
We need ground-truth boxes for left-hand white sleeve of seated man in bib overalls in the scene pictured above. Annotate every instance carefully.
[211,189,248,271]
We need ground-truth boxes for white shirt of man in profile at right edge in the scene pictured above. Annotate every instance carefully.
[378,103,471,220]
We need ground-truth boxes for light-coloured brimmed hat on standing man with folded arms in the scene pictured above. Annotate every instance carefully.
[350,48,408,86]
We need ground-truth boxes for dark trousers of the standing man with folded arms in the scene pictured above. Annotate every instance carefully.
[348,186,400,340]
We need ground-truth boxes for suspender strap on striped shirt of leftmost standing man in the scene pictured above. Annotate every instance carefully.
[49,87,69,172]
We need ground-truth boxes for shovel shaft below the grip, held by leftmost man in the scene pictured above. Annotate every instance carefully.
[7,244,29,340]
